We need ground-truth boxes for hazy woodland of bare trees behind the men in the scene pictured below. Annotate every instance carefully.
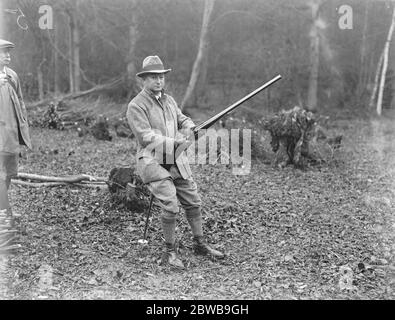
[1,0,395,113]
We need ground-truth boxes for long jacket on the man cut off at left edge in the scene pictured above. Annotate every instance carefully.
[0,67,32,153]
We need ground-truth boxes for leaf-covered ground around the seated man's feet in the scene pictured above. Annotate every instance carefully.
[3,113,395,299]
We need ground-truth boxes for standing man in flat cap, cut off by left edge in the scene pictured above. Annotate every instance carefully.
[0,39,32,250]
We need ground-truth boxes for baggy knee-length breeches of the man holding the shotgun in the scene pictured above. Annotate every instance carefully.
[147,165,201,214]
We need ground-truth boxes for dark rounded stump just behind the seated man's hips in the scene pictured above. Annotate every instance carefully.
[108,168,150,211]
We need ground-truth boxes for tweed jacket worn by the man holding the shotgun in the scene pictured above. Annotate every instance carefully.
[126,89,195,183]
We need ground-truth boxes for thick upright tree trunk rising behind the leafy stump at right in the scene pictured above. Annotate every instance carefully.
[307,1,320,111]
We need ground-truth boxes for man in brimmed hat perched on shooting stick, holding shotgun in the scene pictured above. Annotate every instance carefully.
[127,56,224,268]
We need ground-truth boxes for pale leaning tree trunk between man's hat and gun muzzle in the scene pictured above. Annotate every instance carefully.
[181,0,215,110]
